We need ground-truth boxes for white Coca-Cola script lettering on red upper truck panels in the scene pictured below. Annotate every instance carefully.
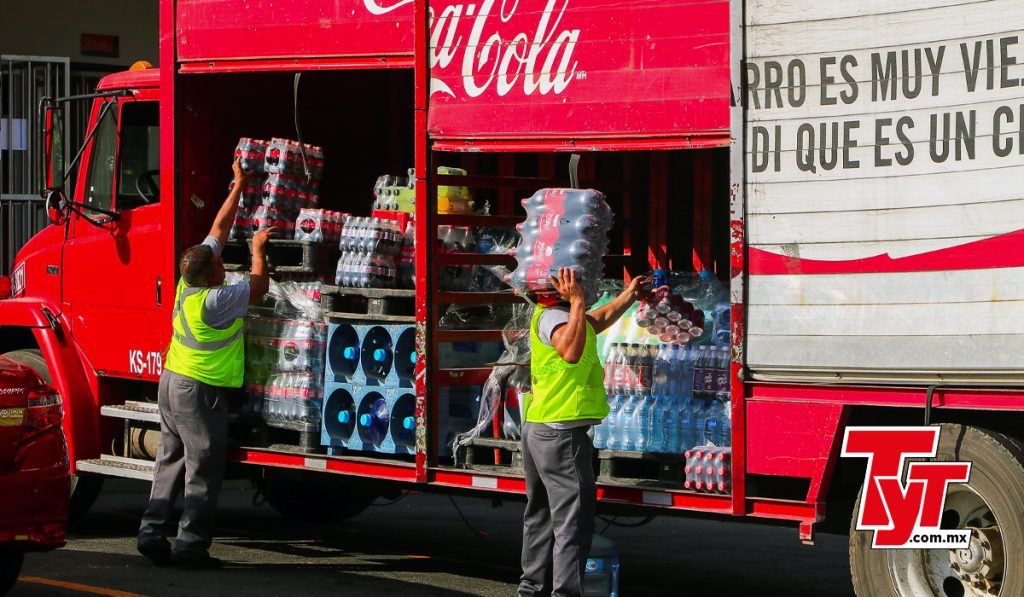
[362,0,584,97]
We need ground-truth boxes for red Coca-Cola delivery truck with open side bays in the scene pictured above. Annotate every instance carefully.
[0,0,1024,595]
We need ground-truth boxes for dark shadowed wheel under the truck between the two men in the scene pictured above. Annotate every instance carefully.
[262,469,380,522]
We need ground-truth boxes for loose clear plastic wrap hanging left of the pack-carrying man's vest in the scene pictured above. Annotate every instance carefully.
[452,304,534,464]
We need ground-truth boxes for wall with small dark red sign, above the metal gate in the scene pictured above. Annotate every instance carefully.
[0,0,160,67]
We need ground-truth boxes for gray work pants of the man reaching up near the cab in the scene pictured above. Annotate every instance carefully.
[138,370,227,556]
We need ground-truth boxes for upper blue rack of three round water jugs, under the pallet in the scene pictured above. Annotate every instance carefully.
[325,322,417,388]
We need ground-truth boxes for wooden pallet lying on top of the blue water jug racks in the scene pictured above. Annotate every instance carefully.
[321,285,416,324]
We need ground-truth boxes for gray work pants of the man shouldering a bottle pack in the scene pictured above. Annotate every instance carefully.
[517,423,597,597]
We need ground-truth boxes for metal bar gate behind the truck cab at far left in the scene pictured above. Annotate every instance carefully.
[0,55,71,274]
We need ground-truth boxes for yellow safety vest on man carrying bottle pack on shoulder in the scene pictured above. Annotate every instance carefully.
[523,306,608,423]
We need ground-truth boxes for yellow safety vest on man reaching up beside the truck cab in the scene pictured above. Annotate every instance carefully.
[164,281,246,388]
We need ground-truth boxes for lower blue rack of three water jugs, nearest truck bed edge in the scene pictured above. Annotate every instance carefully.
[321,383,418,455]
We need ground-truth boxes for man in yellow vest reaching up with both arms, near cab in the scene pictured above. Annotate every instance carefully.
[137,160,274,568]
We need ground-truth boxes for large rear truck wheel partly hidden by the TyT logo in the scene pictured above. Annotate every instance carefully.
[850,424,1024,597]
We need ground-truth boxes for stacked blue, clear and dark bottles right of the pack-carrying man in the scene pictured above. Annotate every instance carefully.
[594,343,731,454]
